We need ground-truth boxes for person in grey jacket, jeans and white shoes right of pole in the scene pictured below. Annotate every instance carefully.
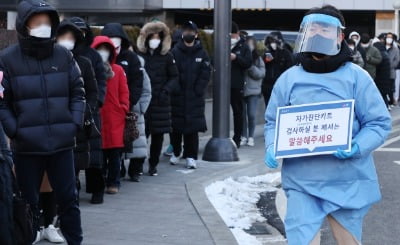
[240,37,265,146]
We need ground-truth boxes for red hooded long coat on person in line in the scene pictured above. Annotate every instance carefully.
[92,36,129,149]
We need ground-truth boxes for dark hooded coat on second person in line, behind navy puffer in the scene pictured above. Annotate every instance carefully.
[57,20,98,169]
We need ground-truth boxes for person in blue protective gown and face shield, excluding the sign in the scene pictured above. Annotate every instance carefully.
[265,6,391,245]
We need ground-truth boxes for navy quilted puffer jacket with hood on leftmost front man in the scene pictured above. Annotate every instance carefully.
[0,1,85,155]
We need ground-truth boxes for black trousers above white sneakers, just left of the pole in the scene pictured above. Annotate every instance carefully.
[171,132,199,160]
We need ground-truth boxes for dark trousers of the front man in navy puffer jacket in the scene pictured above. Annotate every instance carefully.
[14,150,83,245]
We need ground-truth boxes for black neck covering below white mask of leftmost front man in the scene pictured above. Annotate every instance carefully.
[18,36,54,60]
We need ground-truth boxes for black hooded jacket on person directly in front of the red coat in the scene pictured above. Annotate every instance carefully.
[68,17,107,107]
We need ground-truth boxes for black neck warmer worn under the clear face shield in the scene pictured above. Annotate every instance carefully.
[298,41,352,73]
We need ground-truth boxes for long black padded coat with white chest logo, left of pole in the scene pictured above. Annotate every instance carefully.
[171,41,211,134]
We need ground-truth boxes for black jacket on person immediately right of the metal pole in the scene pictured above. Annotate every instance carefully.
[231,39,253,89]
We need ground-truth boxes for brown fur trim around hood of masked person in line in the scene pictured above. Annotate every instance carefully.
[137,21,172,55]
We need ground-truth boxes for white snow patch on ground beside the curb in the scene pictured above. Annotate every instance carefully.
[205,173,281,245]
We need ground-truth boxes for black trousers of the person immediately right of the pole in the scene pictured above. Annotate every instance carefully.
[231,88,243,147]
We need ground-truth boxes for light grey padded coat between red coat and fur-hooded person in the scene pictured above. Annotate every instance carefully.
[124,56,151,159]
